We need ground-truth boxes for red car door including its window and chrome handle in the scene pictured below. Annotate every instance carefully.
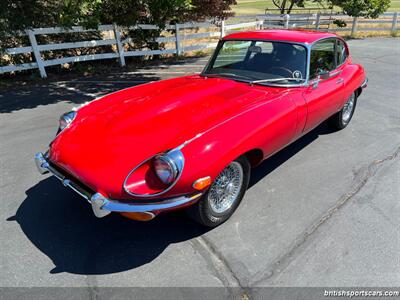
[304,38,343,132]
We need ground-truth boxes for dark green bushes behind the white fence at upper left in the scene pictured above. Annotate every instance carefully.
[0,0,236,58]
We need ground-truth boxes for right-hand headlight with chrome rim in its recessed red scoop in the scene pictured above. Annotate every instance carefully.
[124,149,184,197]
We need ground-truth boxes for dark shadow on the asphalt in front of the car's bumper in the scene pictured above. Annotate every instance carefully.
[8,177,207,275]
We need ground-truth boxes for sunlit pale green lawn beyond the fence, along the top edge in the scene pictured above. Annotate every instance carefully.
[232,0,400,15]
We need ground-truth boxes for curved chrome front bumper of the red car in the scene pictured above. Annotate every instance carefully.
[35,152,202,218]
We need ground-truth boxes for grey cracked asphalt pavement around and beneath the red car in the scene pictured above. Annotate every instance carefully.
[0,38,400,296]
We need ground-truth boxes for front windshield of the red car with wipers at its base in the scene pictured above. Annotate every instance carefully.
[203,40,307,85]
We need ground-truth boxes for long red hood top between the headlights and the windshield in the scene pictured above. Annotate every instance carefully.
[50,75,277,197]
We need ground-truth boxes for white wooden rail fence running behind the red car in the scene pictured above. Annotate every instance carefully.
[0,12,399,78]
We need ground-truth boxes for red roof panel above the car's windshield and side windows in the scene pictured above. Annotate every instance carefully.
[223,29,338,44]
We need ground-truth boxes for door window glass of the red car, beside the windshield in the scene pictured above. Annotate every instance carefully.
[310,39,335,79]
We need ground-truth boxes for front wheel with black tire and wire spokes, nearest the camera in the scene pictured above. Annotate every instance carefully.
[188,156,250,227]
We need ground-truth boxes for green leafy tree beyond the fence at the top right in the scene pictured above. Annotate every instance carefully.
[330,0,390,18]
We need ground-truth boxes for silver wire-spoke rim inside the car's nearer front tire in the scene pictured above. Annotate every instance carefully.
[208,161,243,214]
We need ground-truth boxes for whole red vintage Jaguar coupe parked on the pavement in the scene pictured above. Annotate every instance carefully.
[35,30,367,227]
